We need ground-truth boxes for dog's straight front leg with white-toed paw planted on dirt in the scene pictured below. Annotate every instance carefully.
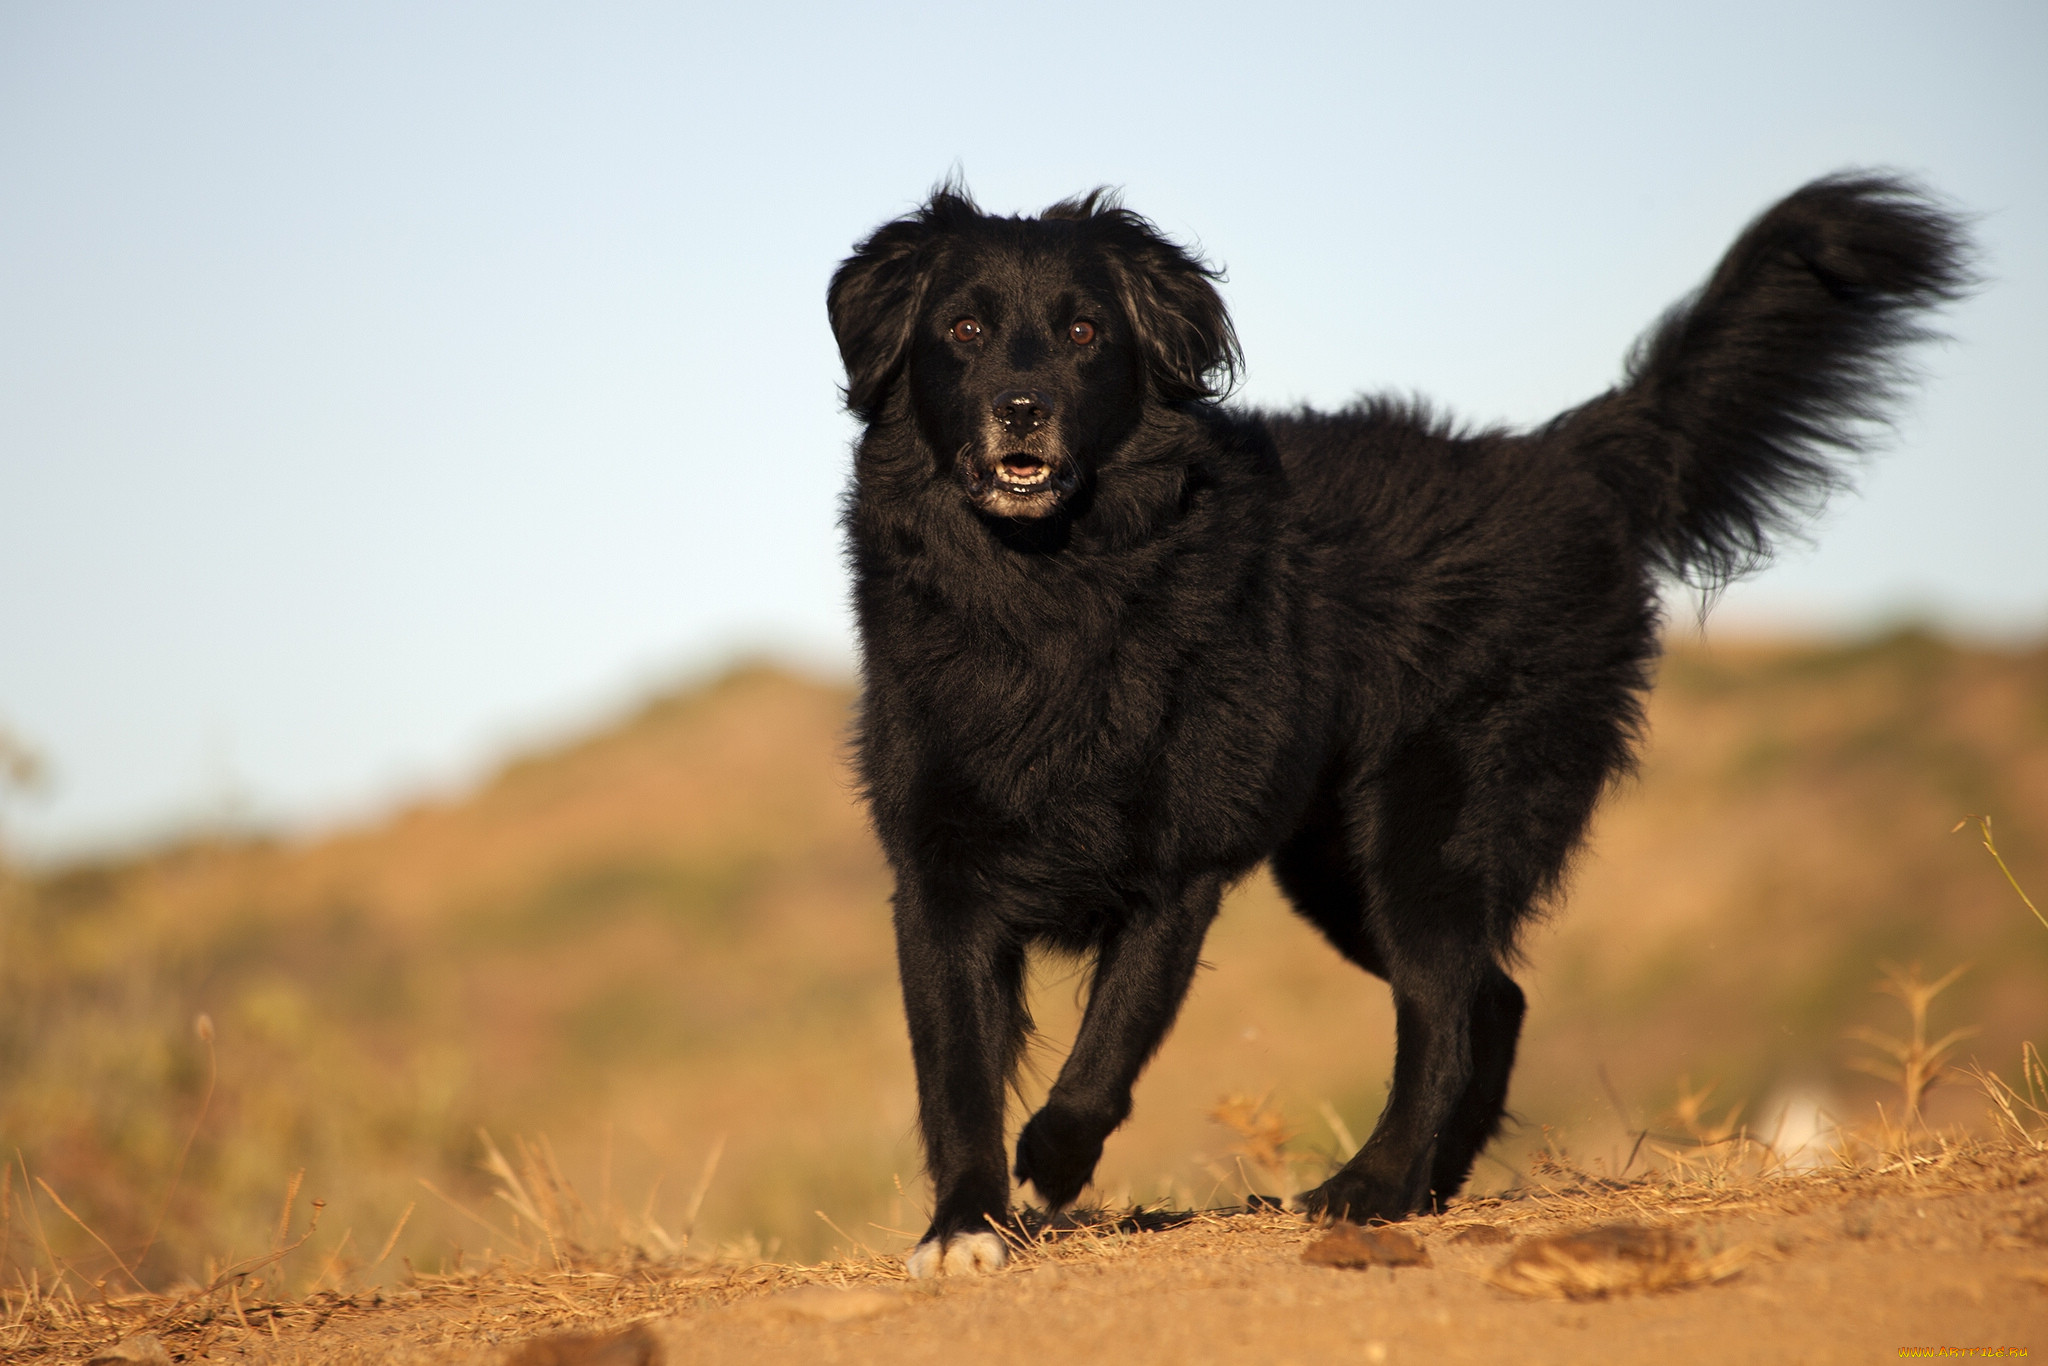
[895,879,1030,1278]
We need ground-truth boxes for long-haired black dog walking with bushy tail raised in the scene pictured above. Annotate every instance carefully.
[829,174,1968,1276]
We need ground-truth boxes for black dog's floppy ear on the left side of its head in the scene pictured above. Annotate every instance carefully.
[825,182,981,422]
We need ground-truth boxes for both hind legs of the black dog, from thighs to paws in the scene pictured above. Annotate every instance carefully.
[1274,688,1651,1219]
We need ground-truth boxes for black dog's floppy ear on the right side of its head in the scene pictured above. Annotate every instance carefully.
[1044,190,1243,403]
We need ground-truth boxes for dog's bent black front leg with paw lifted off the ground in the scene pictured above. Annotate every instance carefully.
[1016,877,1223,1210]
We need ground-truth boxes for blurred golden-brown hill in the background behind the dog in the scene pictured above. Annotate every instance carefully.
[0,631,2048,1286]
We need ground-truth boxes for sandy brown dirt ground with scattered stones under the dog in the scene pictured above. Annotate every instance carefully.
[19,1143,2048,1366]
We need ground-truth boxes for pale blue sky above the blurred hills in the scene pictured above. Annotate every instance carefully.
[0,0,2048,854]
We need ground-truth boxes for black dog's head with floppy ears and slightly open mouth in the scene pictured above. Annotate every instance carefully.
[827,186,1239,518]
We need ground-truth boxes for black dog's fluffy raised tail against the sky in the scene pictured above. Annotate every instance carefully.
[1550,172,1972,590]
